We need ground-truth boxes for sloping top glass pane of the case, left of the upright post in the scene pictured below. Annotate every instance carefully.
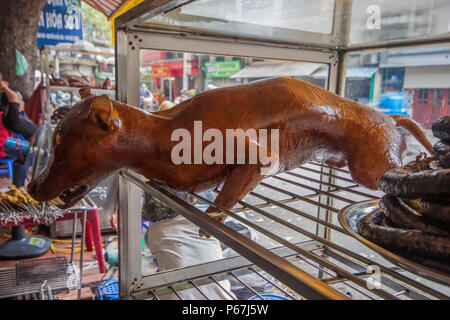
[143,0,334,42]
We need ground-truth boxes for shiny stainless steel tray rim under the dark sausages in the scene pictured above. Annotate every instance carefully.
[339,200,450,285]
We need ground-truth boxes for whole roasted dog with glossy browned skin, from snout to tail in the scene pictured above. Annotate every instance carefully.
[28,78,432,211]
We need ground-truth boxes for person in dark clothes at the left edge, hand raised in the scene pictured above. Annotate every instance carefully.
[0,81,37,139]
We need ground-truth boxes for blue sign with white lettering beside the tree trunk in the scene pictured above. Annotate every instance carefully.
[37,0,83,49]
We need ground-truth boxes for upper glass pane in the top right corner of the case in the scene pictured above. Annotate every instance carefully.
[349,0,450,46]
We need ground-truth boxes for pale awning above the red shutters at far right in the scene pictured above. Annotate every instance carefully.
[403,66,450,89]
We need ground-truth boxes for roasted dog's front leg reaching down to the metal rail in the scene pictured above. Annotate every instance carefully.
[199,164,264,238]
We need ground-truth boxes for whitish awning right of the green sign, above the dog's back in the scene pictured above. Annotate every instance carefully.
[230,62,323,79]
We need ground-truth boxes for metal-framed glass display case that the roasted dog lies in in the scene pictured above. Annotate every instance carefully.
[115,0,450,299]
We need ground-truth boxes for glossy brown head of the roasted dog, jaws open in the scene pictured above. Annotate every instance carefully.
[28,94,121,208]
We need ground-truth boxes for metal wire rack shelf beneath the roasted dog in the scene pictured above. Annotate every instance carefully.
[118,162,450,299]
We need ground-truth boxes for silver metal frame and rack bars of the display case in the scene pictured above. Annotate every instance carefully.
[116,0,450,299]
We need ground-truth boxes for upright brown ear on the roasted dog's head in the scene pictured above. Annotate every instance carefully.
[89,95,119,131]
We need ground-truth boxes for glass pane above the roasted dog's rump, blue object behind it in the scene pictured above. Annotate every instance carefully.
[345,46,450,163]
